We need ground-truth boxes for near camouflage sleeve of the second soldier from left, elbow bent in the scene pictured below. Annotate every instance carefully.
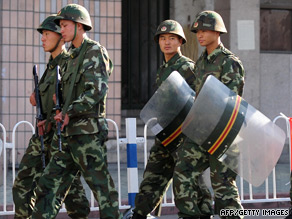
[67,45,113,117]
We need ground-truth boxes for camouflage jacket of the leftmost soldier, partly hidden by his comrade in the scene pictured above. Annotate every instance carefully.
[39,50,69,122]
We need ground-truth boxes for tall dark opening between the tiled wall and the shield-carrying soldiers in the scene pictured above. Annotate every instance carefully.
[122,0,169,110]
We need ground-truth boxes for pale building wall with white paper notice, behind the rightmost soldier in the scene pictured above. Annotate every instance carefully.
[170,0,292,119]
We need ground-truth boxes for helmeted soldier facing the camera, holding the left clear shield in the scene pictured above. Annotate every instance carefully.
[132,20,213,219]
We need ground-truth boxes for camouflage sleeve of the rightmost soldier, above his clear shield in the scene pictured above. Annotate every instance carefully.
[221,57,245,96]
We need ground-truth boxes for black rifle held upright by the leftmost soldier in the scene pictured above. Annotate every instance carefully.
[32,65,46,168]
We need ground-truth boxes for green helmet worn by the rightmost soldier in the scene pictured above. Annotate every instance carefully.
[191,11,227,33]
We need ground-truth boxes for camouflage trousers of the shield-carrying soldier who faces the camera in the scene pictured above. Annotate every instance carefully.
[133,140,213,216]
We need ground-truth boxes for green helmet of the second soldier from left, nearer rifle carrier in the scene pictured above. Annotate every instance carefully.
[55,4,92,30]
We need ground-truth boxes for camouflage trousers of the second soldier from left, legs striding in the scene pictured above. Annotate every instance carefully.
[32,134,122,219]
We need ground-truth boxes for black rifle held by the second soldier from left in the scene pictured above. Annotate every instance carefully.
[55,65,62,151]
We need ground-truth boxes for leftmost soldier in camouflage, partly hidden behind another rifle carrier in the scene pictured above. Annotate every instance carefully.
[12,15,90,218]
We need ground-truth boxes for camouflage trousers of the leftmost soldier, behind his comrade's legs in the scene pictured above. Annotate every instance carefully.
[12,130,90,218]
